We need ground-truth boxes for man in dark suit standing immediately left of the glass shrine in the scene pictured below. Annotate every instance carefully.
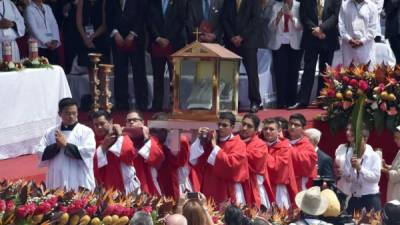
[147,0,186,111]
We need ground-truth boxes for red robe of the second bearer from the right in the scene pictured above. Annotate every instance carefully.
[267,139,298,203]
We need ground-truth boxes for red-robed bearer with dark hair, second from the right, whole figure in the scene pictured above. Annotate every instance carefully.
[262,119,298,209]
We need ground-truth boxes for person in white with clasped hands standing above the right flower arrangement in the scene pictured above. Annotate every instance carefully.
[339,0,378,66]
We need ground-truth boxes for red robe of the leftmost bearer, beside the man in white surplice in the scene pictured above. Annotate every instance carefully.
[93,136,137,192]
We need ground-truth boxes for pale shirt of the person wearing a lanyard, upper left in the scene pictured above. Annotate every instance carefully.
[25,2,60,48]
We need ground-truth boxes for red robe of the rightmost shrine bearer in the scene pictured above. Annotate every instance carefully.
[292,137,318,190]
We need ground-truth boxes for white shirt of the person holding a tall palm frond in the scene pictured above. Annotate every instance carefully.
[343,145,382,197]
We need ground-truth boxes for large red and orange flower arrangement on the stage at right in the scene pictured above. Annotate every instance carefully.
[319,64,400,132]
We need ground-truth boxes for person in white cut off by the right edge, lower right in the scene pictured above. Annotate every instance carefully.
[382,126,400,202]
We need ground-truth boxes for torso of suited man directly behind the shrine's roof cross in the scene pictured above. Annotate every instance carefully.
[186,0,224,43]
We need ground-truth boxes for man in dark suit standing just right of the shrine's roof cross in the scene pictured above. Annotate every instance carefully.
[222,0,261,113]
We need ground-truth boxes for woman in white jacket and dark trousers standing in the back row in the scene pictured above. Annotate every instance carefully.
[268,0,303,108]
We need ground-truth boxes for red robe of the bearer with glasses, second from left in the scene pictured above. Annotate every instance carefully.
[134,137,164,196]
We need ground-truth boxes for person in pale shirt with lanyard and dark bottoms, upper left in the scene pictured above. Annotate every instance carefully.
[25,0,61,64]
